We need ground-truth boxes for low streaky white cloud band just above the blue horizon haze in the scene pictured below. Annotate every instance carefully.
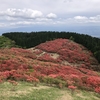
[0,14,100,27]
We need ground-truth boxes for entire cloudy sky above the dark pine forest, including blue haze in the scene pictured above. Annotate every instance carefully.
[0,0,100,37]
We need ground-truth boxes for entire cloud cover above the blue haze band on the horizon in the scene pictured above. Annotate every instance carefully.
[0,0,100,30]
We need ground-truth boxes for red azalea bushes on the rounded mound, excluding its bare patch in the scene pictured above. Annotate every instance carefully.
[36,39,97,69]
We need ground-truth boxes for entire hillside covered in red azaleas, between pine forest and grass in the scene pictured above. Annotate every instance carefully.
[0,39,100,93]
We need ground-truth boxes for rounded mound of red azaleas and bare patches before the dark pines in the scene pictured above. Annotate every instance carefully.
[31,39,100,70]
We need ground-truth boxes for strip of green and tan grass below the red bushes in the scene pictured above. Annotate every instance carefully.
[0,82,100,100]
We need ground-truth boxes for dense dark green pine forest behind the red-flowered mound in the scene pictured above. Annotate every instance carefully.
[3,31,100,63]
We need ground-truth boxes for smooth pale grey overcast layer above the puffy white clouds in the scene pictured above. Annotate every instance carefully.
[0,0,100,15]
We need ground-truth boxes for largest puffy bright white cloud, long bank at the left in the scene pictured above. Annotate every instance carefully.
[0,9,43,19]
